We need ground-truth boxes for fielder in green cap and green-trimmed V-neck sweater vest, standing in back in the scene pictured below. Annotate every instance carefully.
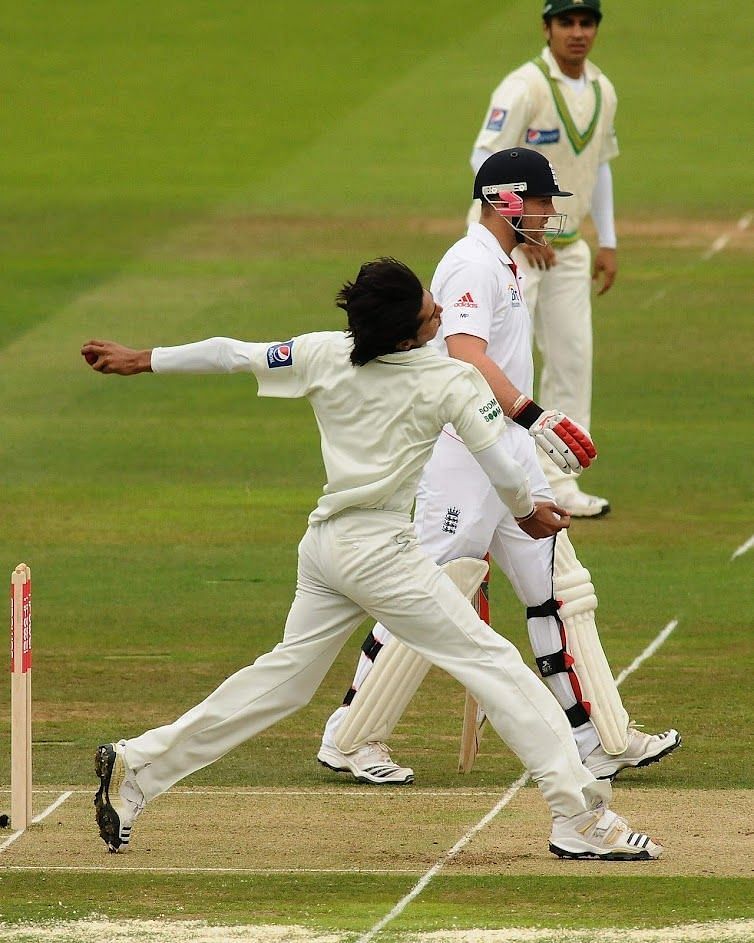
[470,0,618,517]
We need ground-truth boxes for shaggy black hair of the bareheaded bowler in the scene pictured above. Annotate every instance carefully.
[335,258,424,367]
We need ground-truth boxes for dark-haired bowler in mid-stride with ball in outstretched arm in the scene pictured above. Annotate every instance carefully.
[82,259,662,860]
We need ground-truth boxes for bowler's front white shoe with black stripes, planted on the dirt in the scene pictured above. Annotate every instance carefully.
[550,803,663,861]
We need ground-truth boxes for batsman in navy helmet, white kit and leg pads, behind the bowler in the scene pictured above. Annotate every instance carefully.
[318,148,681,785]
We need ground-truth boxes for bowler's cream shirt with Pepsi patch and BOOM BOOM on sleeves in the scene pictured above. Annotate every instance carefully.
[152,331,505,524]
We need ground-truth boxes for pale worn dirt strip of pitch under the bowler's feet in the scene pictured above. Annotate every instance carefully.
[2,787,754,877]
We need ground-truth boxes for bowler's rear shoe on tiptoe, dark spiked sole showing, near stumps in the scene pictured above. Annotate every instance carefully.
[94,740,145,854]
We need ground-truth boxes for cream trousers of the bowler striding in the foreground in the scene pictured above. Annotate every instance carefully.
[125,510,610,816]
